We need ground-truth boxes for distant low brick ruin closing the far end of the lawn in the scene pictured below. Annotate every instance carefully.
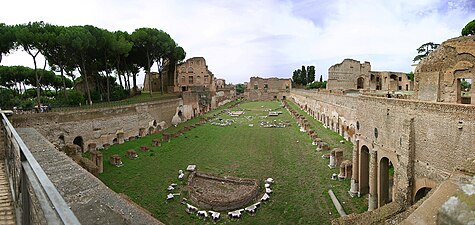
[244,77,292,100]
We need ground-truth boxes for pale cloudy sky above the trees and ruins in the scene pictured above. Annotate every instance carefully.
[0,0,475,83]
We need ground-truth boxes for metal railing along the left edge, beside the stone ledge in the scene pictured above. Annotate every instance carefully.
[0,112,80,225]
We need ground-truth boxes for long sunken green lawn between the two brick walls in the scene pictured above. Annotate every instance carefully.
[96,102,366,224]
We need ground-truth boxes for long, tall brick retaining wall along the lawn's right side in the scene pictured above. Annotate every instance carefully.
[291,89,475,207]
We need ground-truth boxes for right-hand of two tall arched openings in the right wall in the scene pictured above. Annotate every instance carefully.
[379,157,394,207]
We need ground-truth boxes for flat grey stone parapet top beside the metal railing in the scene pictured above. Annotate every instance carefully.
[17,128,162,225]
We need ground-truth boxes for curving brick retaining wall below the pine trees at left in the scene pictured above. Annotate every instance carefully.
[11,99,184,151]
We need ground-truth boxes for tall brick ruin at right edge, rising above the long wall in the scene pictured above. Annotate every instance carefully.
[414,36,475,105]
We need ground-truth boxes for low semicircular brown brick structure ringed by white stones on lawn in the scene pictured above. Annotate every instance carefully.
[188,172,259,211]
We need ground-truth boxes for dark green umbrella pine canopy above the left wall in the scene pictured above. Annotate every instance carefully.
[0,21,186,109]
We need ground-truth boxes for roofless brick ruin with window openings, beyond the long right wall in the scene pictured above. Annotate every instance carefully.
[327,59,414,91]
